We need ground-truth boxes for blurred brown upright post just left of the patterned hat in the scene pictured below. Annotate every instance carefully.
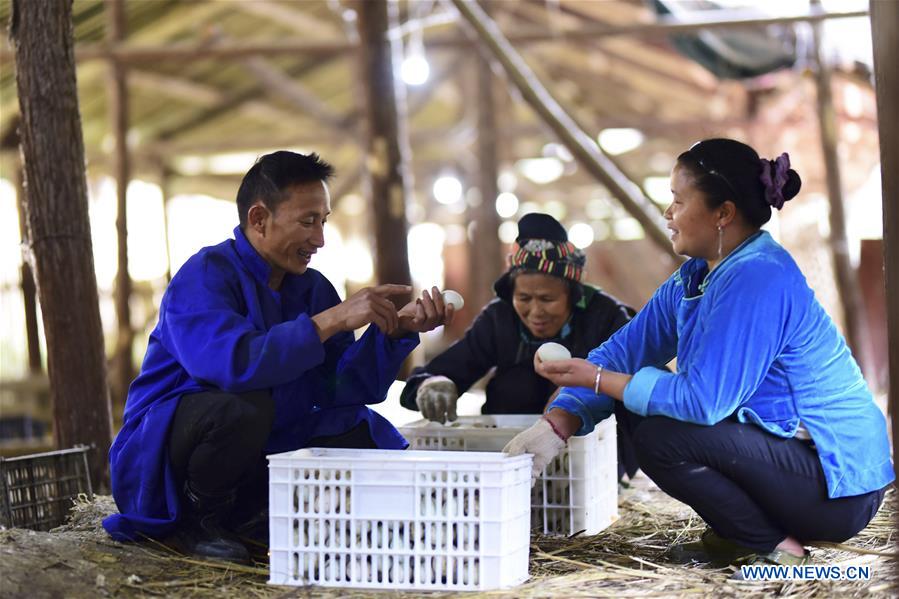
[468,48,503,313]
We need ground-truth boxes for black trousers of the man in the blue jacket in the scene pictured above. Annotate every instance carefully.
[168,391,376,520]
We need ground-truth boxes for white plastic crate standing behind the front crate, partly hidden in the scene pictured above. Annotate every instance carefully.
[399,414,618,535]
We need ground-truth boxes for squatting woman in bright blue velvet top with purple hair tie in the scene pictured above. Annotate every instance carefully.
[507,139,894,564]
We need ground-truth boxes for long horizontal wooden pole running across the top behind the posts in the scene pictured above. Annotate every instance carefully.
[0,10,868,64]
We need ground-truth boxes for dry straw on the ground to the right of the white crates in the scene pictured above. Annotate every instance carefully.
[514,483,899,599]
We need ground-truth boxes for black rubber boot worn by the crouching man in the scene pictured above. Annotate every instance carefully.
[178,483,250,563]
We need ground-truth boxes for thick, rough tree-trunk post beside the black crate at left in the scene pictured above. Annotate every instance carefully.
[10,0,112,488]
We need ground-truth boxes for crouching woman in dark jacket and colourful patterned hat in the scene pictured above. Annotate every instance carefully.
[400,213,636,475]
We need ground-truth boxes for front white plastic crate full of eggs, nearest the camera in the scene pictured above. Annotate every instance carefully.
[268,448,532,590]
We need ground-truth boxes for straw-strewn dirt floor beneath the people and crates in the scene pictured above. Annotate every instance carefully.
[0,476,899,599]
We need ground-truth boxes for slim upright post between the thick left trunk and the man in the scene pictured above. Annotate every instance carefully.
[106,0,134,405]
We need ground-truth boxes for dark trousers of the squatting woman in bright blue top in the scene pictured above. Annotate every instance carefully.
[635,416,886,552]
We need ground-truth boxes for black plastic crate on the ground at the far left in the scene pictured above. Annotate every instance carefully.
[0,447,94,530]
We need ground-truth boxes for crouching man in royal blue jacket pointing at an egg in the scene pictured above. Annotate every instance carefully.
[103,151,452,561]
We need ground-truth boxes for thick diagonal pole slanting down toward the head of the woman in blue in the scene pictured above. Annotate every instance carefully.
[452,0,680,260]
